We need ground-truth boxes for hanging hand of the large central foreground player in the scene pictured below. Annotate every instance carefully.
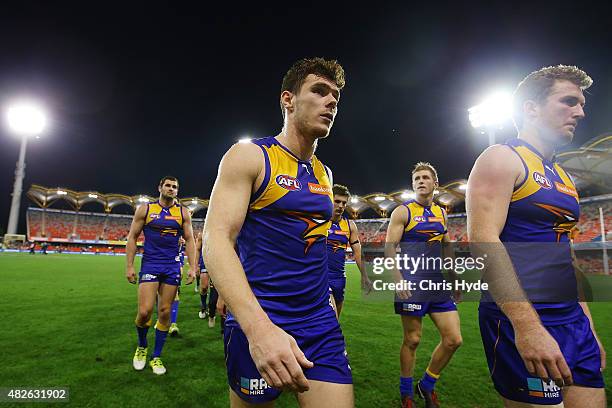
[248,321,314,392]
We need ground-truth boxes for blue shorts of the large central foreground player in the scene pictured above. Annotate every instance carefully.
[224,308,353,404]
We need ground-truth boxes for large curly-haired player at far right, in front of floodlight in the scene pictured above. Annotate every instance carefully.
[466,65,606,408]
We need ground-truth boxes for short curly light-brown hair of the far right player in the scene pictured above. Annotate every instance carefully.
[512,65,593,129]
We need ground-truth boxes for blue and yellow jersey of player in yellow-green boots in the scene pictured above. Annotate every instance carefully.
[142,202,183,264]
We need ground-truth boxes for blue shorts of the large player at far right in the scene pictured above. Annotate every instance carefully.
[478,310,604,405]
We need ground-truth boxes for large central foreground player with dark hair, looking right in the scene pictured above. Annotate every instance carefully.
[204,58,354,408]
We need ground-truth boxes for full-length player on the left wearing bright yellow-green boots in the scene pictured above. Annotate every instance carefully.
[126,176,196,375]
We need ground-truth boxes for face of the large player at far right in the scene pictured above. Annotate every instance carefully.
[535,80,585,146]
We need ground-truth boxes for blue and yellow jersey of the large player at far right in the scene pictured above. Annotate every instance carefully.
[488,138,580,322]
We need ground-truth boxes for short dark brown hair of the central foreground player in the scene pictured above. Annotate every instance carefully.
[281,57,346,115]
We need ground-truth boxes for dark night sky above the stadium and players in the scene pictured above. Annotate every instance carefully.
[0,2,612,233]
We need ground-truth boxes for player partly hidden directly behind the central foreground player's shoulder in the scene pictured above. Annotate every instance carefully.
[327,184,372,318]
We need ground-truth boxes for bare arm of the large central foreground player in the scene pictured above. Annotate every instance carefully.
[202,144,312,392]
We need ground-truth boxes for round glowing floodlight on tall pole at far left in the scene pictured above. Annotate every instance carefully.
[5,100,47,234]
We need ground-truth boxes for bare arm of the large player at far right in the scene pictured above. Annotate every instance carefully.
[466,145,572,385]
